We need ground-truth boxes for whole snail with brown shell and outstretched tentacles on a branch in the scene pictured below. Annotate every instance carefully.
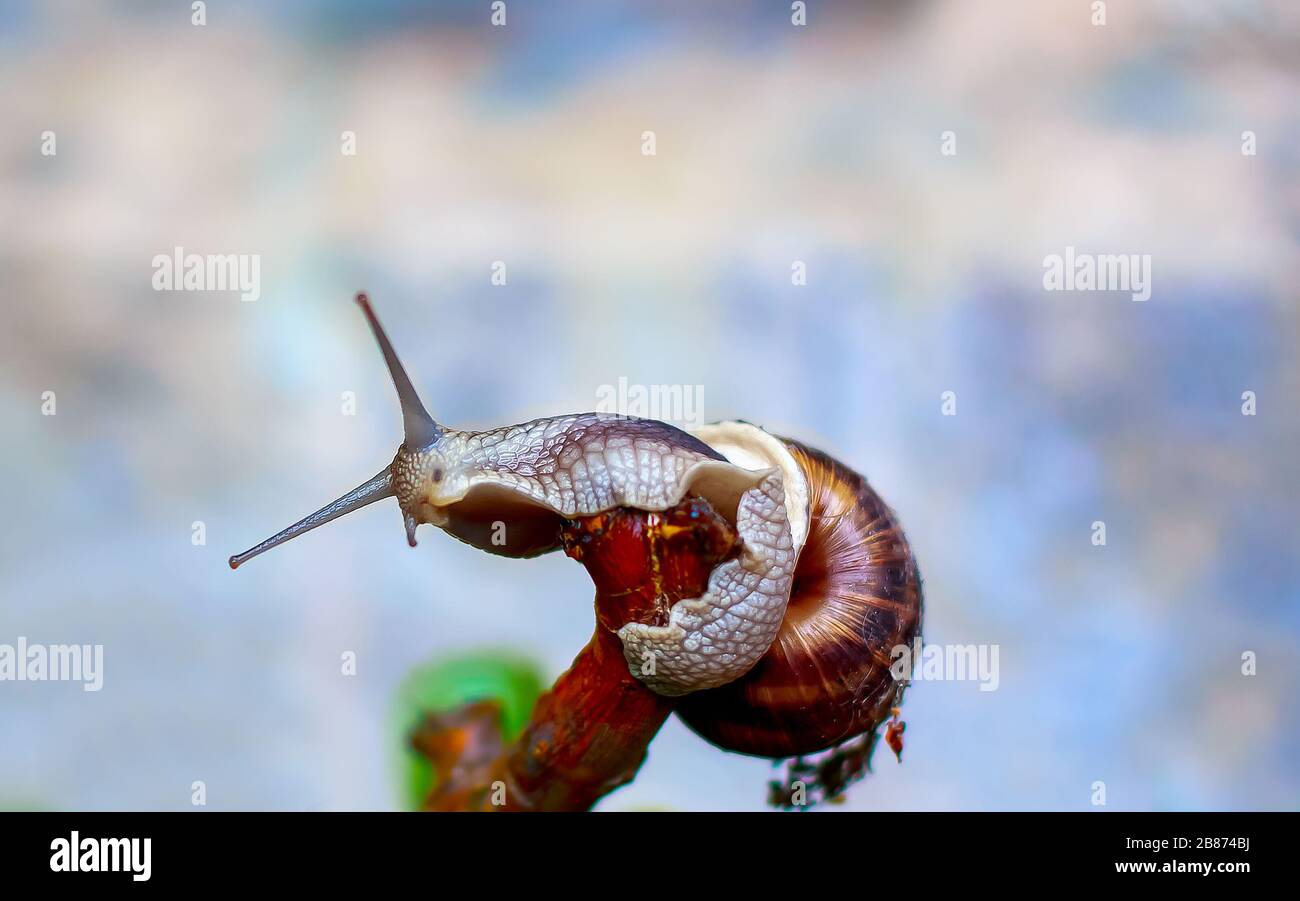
[230,294,922,795]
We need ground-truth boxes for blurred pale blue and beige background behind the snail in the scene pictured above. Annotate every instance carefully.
[0,0,1300,810]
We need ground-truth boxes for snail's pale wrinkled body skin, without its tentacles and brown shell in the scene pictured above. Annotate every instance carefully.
[391,413,807,696]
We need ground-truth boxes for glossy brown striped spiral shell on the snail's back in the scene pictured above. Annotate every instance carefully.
[677,438,922,758]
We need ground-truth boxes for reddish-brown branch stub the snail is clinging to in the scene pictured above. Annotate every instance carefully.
[412,498,737,810]
